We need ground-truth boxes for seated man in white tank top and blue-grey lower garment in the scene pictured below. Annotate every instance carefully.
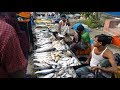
[76,34,118,78]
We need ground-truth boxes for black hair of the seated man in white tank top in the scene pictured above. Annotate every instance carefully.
[95,34,113,46]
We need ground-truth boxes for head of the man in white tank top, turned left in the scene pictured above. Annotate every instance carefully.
[94,34,112,47]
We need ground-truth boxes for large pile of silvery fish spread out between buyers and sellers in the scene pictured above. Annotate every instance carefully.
[32,17,80,78]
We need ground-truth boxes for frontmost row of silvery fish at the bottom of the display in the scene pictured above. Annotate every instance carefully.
[35,68,77,78]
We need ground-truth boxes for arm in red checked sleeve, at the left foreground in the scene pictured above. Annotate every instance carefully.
[3,26,27,78]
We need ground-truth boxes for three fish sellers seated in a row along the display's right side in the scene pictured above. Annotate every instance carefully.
[55,15,118,78]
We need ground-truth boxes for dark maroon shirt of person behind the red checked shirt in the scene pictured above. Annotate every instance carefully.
[0,12,30,56]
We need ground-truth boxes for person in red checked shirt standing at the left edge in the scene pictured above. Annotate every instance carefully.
[0,12,27,78]
